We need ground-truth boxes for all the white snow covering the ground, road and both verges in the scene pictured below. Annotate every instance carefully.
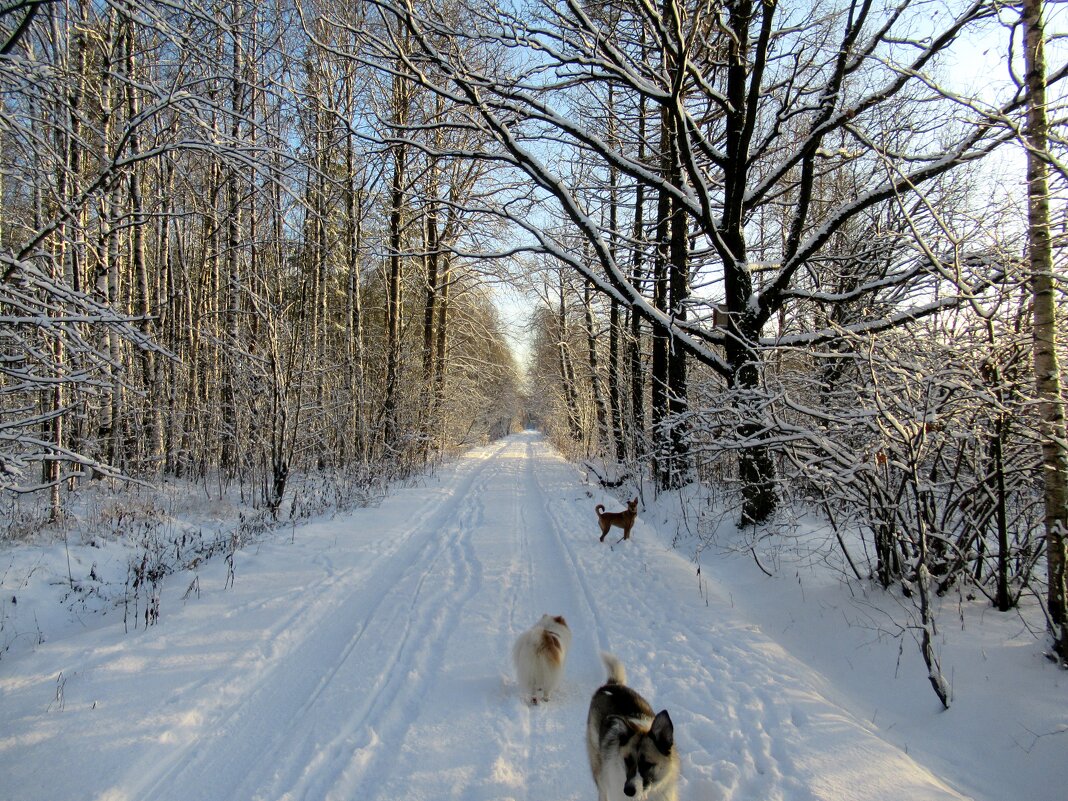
[0,433,1068,801]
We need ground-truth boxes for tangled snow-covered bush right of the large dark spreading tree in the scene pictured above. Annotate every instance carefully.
[784,328,1041,609]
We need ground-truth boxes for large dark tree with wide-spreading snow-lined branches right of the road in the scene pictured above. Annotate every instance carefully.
[354,0,1063,521]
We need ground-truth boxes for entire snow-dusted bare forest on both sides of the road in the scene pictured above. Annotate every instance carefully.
[0,0,1068,679]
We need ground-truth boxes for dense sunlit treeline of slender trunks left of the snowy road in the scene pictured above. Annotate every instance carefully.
[0,0,518,514]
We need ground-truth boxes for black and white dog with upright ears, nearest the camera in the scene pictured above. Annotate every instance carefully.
[586,654,679,801]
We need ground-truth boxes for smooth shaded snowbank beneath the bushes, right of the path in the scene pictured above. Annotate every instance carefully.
[645,499,1068,801]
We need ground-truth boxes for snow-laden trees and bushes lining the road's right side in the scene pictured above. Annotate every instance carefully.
[339,0,1068,679]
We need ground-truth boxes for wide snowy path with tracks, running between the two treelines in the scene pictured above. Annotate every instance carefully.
[0,434,974,801]
